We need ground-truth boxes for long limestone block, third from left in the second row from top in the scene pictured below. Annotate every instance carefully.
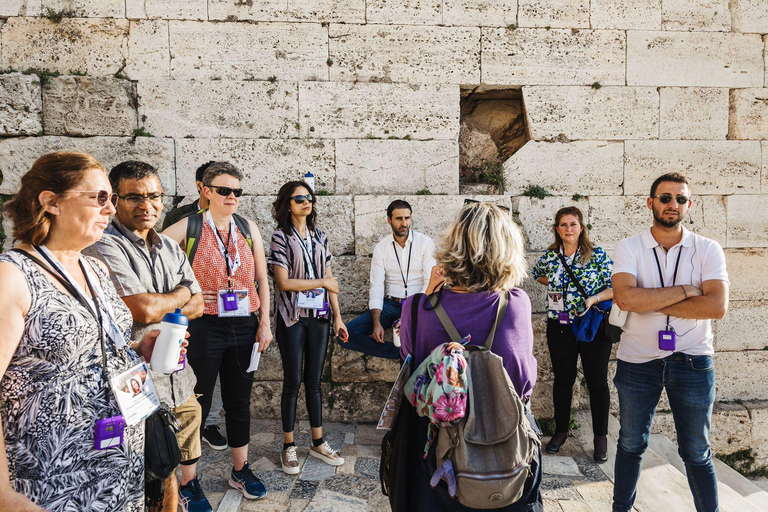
[170,21,328,81]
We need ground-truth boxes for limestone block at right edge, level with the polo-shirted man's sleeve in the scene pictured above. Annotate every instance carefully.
[725,249,768,300]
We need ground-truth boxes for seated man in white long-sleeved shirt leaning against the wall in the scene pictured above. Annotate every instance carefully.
[336,199,435,359]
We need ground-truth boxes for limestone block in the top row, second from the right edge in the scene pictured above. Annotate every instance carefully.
[661,0,731,32]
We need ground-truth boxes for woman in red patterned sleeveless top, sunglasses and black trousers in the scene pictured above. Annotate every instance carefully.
[163,162,272,499]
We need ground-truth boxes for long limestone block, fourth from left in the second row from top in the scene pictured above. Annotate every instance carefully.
[322,25,480,84]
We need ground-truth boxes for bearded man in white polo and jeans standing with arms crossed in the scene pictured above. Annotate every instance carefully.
[612,173,728,512]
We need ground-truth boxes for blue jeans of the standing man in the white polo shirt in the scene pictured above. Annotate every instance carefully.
[613,352,718,512]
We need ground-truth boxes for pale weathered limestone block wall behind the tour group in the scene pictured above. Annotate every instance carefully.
[0,0,768,462]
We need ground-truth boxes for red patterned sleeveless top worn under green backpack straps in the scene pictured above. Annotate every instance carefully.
[192,218,261,315]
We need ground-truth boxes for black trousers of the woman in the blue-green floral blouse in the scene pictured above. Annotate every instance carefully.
[547,318,612,436]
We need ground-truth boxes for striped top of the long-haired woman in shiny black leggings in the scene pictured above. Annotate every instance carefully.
[267,228,333,327]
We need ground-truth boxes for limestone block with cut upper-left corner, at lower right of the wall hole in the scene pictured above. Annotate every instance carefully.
[504,141,624,196]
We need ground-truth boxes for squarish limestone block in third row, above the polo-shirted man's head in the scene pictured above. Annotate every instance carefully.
[659,87,728,140]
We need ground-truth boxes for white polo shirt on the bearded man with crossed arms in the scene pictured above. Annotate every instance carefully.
[613,228,728,363]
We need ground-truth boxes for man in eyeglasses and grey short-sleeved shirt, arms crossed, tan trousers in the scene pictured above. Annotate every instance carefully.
[83,161,212,512]
